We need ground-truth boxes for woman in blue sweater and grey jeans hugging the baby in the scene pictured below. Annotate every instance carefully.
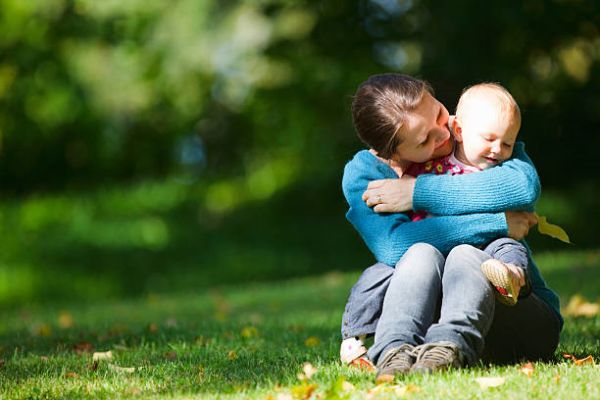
[342,74,562,379]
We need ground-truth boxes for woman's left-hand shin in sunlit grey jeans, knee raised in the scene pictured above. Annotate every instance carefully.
[368,243,444,363]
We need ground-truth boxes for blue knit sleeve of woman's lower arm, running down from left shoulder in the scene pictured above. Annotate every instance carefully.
[342,151,507,266]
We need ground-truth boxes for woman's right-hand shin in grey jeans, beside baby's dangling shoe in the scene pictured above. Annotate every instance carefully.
[425,245,495,364]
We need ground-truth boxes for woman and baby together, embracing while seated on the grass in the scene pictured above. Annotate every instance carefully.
[340,74,563,381]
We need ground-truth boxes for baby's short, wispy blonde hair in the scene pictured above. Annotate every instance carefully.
[455,82,521,128]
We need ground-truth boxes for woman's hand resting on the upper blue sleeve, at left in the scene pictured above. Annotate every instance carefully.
[362,175,416,213]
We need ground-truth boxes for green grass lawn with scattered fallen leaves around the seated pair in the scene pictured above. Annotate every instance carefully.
[0,251,600,399]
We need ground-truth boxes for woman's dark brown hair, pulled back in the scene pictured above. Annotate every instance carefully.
[352,74,433,159]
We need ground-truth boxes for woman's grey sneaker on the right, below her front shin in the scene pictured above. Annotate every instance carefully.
[411,342,462,374]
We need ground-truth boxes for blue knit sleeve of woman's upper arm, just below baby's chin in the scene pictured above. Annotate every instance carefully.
[413,142,541,215]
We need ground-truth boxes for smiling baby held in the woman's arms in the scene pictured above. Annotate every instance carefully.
[340,83,530,365]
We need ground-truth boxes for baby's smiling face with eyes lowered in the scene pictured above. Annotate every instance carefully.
[457,104,519,169]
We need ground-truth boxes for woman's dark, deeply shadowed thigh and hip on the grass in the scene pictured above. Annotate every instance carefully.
[481,294,560,363]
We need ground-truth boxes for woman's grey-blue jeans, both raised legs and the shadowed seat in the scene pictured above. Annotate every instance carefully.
[342,244,560,364]
